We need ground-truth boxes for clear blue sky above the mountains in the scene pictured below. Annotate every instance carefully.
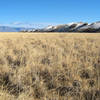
[0,0,100,25]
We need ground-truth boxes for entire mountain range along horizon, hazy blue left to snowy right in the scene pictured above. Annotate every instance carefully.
[0,21,100,32]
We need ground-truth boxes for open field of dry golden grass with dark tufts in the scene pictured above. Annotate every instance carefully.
[0,33,100,100]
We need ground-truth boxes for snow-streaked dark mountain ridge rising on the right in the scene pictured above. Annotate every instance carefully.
[32,21,100,32]
